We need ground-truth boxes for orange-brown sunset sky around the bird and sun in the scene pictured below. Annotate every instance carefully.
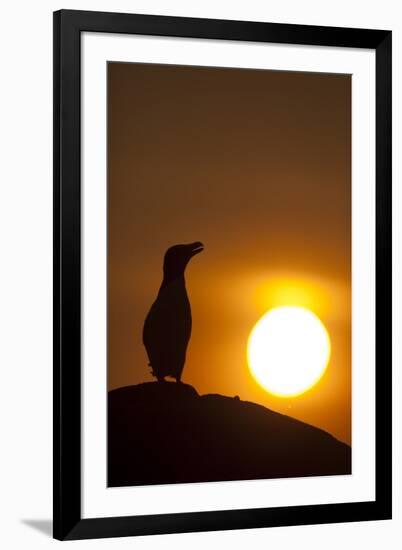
[108,63,351,443]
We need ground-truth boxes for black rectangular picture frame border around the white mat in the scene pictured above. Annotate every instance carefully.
[53,10,392,540]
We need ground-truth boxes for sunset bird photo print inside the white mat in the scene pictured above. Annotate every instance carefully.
[107,62,352,487]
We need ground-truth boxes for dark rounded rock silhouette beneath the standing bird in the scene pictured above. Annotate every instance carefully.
[108,382,351,487]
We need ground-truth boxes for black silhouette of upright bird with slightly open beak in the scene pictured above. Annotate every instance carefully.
[142,241,204,382]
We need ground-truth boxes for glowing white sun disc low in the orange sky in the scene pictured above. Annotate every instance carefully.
[247,306,331,397]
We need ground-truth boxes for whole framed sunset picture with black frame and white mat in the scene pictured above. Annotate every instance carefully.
[54,10,391,540]
